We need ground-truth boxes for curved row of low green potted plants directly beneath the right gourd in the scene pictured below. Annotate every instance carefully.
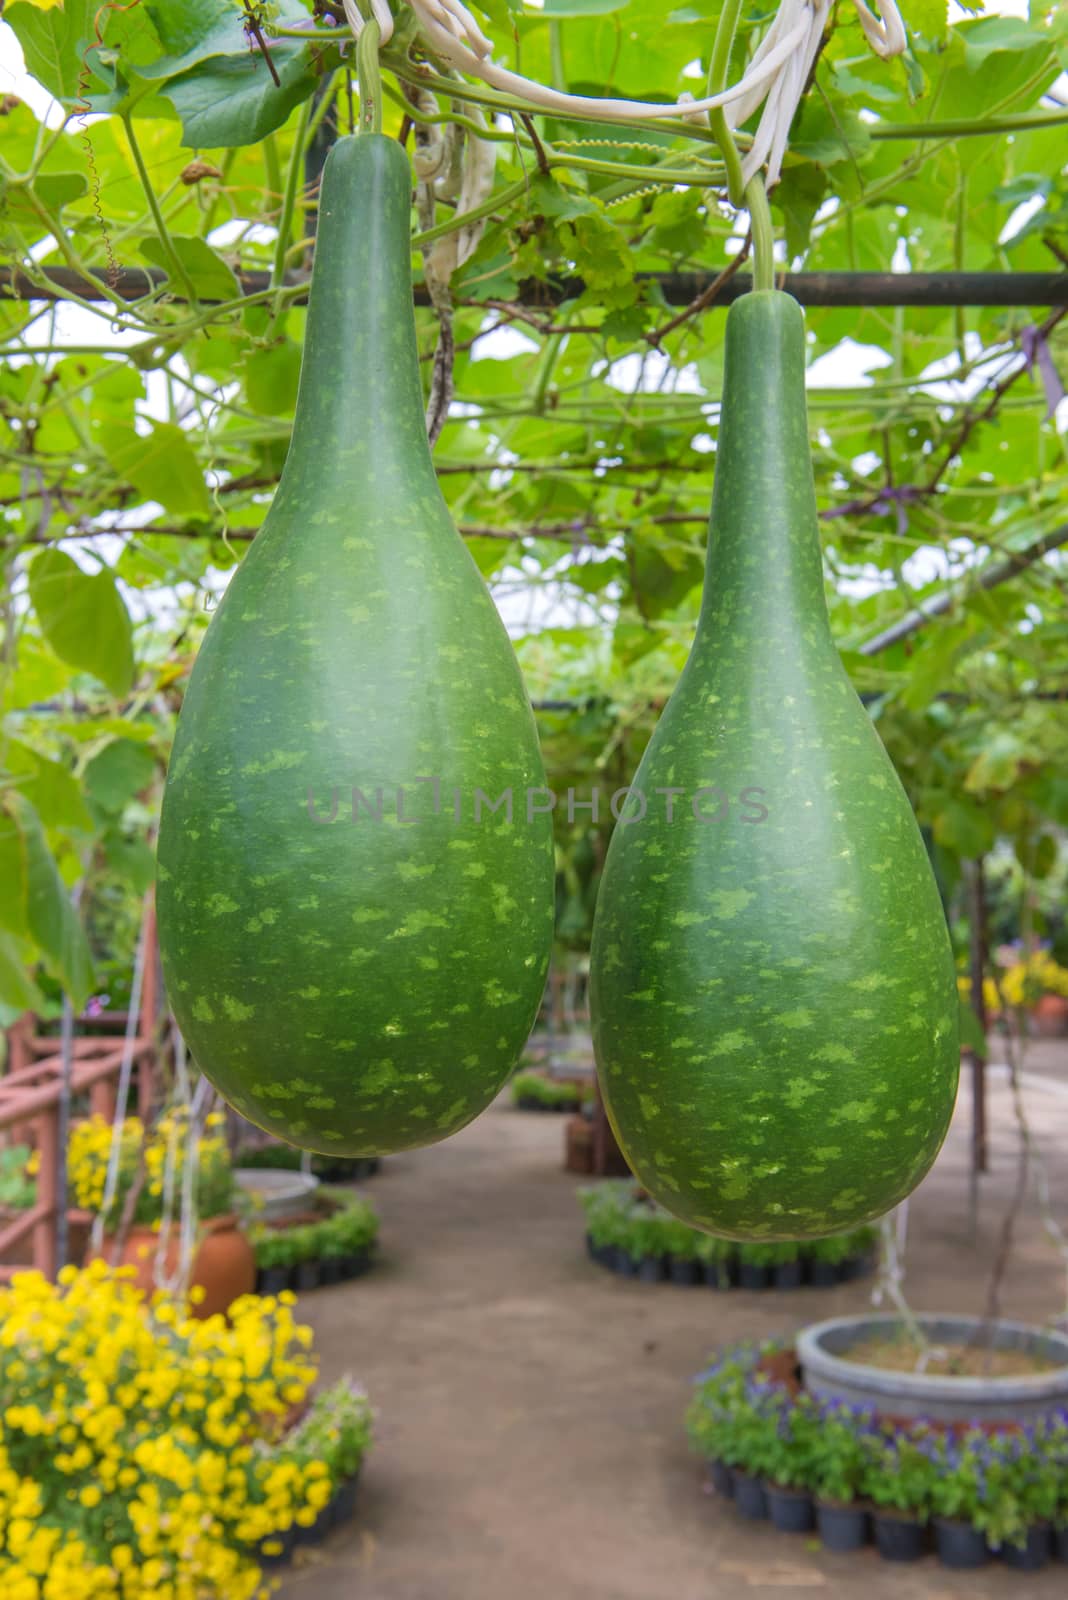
[579,1179,876,1290]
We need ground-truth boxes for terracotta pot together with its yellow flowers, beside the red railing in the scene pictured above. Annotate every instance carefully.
[77,1107,256,1317]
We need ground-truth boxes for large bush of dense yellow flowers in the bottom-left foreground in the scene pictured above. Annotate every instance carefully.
[0,1261,358,1600]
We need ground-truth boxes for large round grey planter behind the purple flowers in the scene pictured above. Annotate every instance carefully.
[796,1317,1068,1422]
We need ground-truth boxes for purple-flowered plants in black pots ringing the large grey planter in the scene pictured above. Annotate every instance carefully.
[686,1346,1068,1570]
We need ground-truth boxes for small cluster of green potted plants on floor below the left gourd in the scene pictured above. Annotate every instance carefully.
[253,1189,379,1294]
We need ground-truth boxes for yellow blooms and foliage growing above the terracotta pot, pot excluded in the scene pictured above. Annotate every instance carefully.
[67,1107,233,1229]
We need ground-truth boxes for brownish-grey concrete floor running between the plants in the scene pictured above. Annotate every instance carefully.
[281,1043,1068,1600]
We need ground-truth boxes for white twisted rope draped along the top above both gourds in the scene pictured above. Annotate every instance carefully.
[378,0,907,187]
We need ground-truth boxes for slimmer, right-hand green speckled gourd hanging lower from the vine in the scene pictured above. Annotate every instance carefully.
[592,291,959,1238]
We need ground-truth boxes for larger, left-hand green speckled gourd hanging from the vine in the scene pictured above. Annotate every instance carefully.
[158,134,553,1155]
